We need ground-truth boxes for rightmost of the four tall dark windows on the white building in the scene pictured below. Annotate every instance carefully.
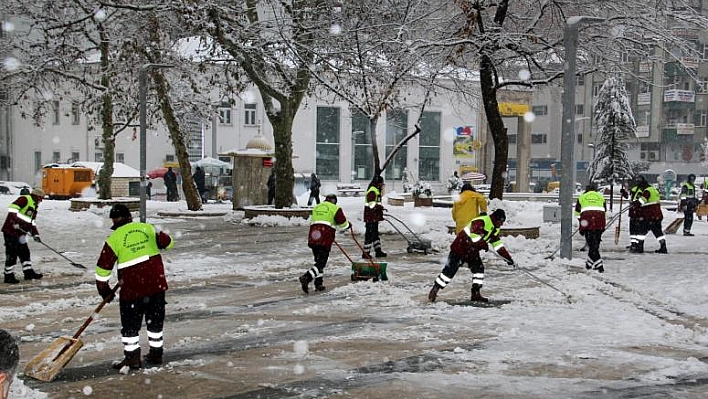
[418,112,442,181]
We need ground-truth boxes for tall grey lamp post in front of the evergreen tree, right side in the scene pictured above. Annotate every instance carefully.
[559,16,605,259]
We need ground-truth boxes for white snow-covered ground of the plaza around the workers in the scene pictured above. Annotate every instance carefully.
[0,194,708,399]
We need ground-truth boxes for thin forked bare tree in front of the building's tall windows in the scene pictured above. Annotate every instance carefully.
[312,0,450,182]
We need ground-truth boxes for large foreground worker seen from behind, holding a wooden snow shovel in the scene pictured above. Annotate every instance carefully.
[96,204,174,370]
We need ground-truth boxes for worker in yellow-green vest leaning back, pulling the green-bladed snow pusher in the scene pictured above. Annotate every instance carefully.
[300,194,352,294]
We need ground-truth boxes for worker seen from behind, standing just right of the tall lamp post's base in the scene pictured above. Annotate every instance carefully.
[575,183,607,273]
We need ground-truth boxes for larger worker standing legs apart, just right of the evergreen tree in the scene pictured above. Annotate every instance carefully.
[630,176,668,254]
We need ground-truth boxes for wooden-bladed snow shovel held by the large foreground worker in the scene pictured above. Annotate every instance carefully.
[25,284,120,382]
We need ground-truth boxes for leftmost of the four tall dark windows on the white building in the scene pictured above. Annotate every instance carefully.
[315,107,341,181]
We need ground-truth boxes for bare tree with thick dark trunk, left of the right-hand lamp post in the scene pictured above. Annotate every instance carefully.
[447,0,708,198]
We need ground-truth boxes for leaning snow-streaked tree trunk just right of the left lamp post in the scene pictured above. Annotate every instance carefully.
[150,70,202,211]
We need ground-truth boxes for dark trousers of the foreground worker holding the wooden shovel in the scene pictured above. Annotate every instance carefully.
[120,291,166,347]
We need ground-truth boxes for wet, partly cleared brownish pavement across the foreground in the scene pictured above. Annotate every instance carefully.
[0,214,708,399]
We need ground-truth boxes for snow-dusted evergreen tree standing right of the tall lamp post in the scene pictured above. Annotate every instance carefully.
[588,76,637,184]
